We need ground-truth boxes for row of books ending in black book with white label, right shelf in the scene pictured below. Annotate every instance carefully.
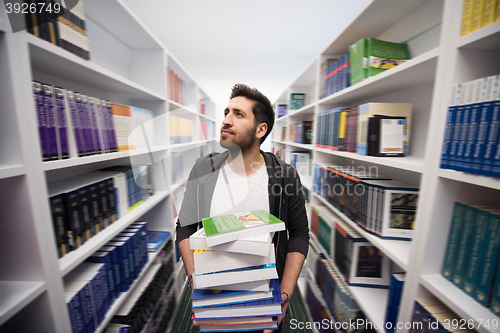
[316,103,412,157]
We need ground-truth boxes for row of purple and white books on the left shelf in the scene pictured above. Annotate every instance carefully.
[32,81,154,161]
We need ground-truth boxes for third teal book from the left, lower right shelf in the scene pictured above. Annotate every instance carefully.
[463,209,490,296]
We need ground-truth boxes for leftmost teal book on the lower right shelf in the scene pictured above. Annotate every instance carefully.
[442,202,466,281]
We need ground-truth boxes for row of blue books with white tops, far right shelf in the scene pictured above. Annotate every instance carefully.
[440,75,500,178]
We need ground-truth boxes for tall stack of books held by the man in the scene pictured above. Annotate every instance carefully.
[190,210,285,332]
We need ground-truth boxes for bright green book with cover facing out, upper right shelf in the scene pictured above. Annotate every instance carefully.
[366,38,410,76]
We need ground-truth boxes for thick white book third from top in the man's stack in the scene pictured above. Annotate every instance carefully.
[193,243,276,274]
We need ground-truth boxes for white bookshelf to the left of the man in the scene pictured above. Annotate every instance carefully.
[0,0,215,333]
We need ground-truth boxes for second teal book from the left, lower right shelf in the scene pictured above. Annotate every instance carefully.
[452,205,477,288]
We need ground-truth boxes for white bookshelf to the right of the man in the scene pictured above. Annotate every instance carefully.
[272,0,500,333]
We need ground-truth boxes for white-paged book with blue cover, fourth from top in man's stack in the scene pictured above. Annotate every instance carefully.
[193,264,278,290]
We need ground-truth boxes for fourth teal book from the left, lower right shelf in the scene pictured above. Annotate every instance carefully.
[475,209,500,306]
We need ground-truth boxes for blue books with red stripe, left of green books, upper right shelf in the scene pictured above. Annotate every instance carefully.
[319,52,351,99]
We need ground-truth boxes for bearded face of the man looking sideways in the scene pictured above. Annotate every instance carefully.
[220,96,257,152]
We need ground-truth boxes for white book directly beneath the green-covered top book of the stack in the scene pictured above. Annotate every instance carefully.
[189,228,272,256]
